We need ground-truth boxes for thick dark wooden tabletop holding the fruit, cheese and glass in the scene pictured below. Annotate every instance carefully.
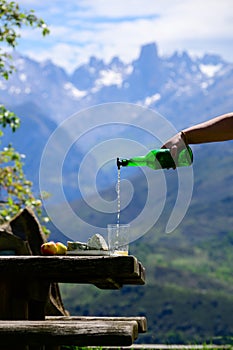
[0,256,145,289]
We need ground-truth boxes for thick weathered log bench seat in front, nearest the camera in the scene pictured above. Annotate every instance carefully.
[0,320,138,346]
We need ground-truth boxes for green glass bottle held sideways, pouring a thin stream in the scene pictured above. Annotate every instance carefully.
[117,146,193,170]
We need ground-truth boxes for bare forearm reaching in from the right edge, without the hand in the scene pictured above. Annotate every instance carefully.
[183,113,233,144]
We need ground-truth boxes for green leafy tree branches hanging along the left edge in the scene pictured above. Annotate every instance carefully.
[0,0,49,233]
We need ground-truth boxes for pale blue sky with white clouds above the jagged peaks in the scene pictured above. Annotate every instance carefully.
[17,0,233,73]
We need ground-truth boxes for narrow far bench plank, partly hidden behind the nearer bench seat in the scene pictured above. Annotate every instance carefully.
[46,316,147,333]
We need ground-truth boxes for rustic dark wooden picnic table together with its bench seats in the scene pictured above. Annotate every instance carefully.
[0,256,146,349]
